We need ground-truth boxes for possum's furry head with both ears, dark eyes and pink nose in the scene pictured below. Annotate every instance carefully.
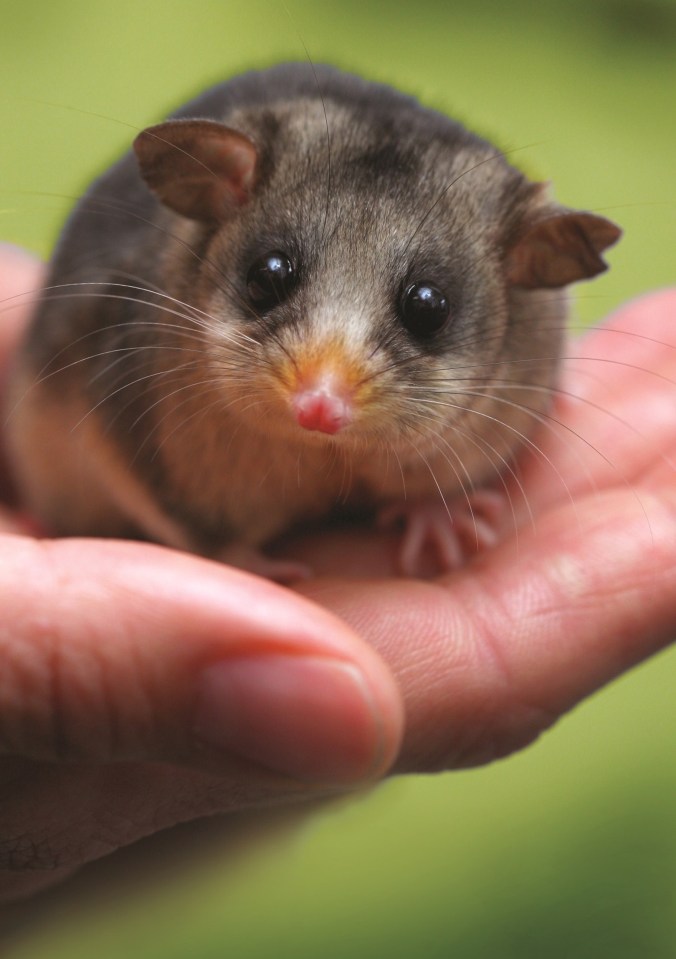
[135,73,620,466]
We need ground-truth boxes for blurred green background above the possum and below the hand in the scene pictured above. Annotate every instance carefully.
[0,0,676,959]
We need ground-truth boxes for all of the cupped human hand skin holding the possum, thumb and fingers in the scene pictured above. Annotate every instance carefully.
[0,248,676,903]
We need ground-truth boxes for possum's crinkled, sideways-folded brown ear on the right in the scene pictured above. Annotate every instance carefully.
[505,207,622,289]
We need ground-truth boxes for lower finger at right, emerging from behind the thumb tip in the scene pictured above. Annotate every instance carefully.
[302,490,676,771]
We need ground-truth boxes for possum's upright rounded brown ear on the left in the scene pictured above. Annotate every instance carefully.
[134,120,258,222]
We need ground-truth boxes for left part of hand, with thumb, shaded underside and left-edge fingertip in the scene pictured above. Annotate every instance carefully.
[0,244,402,903]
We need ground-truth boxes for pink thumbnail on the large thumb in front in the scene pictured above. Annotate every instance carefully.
[195,656,382,783]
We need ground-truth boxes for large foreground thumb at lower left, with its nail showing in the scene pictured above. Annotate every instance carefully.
[0,537,402,793]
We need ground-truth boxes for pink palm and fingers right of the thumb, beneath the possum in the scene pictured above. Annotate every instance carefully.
[291,289,676,772]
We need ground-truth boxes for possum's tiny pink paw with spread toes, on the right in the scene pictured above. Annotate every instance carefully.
[378,490,505,577]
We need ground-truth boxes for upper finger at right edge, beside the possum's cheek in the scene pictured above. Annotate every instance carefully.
[513,289,676,514]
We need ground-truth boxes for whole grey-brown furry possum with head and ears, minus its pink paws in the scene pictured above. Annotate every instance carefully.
[10,65,619,576]
